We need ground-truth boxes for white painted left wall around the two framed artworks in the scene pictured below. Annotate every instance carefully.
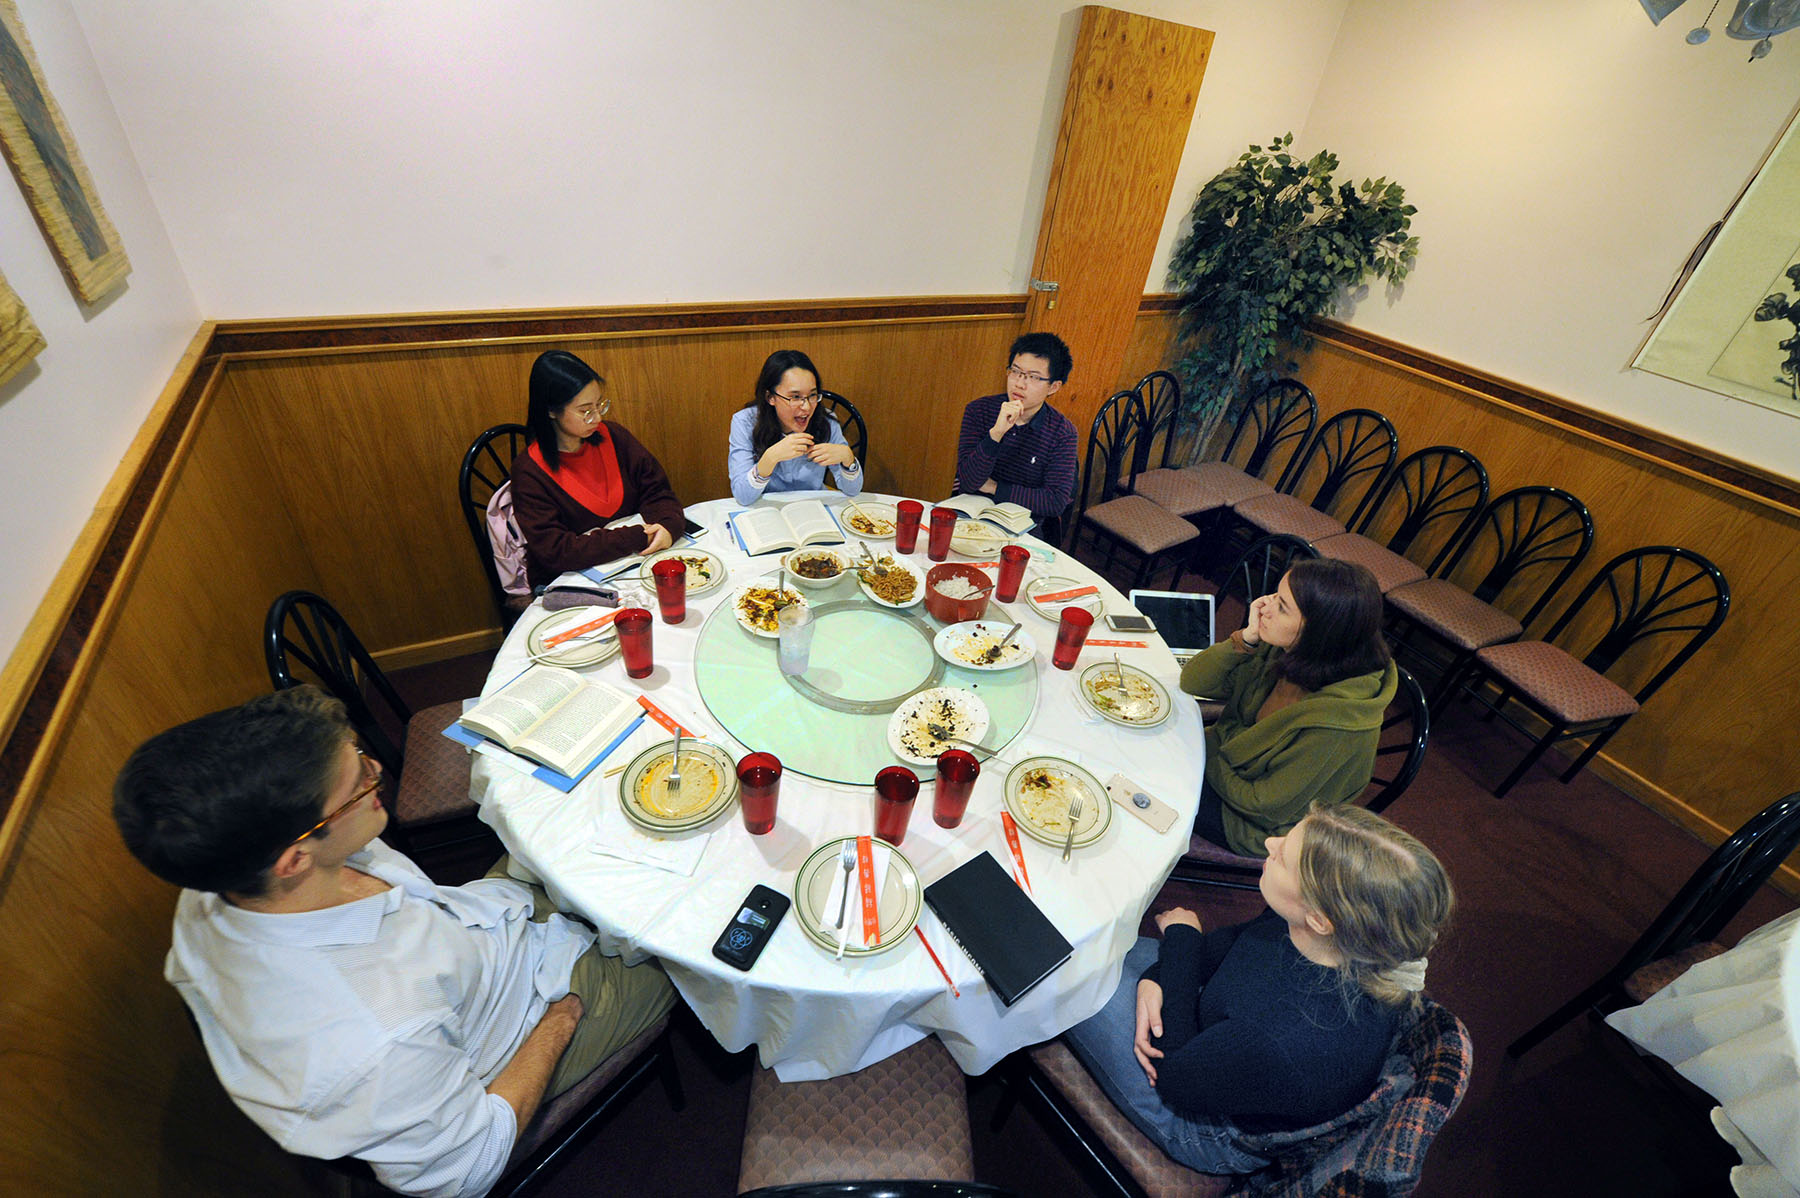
[0,0,200,658]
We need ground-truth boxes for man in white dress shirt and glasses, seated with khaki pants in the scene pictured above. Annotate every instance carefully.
[113,687,675,1194]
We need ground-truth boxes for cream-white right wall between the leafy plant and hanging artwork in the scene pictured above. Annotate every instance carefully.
[1296,0,1800,491]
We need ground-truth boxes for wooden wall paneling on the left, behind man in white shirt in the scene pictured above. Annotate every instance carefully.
[0,386,313,1194]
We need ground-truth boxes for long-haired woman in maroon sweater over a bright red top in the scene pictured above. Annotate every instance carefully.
[513,349,684,588]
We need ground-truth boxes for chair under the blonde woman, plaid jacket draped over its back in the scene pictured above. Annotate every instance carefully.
[995,998,1474,1198]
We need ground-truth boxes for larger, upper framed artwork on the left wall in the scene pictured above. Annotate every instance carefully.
[0,0,131,304]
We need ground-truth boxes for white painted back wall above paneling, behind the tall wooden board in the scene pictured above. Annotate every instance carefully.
[76,0,1345,318]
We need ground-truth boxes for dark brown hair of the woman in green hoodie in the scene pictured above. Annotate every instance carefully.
[1280,558,1390,691]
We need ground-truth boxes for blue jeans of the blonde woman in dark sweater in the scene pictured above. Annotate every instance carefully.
[1064,939,1269,1173]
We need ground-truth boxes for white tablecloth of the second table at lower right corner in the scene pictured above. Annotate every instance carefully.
[1606,912,1800,1193]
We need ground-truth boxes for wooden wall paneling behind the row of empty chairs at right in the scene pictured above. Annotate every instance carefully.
[1301,330,1800,842]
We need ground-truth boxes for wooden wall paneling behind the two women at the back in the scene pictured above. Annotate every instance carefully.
[220,307,1017,660]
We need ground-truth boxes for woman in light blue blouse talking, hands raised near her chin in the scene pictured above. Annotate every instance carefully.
[725,349,862,507]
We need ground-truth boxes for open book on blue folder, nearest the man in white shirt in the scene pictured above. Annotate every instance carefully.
[445,666,644,790]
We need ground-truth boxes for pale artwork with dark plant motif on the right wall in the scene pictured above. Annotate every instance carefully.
[1631,108,1800,416]
